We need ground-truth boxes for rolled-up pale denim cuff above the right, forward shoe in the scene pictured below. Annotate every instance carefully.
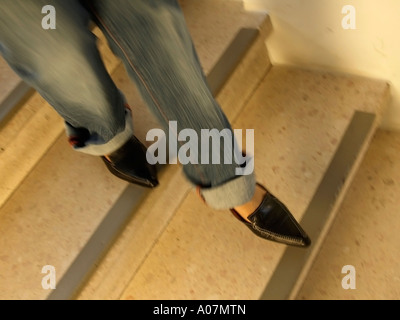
[199,173,256,210]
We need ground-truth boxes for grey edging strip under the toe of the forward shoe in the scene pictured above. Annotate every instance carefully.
[260,111,376,300]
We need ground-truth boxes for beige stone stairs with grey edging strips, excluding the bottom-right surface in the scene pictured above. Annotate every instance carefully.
[0,0,389,300]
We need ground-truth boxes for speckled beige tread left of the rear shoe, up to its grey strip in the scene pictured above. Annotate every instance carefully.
[0,136,125,299]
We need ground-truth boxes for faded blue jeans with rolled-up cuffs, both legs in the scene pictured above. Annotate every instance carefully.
[0,0,255,209]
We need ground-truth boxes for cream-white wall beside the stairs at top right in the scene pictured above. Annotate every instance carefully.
[244,0,400,130]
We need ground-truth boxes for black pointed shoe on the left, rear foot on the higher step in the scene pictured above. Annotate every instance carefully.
[101,136,158,188]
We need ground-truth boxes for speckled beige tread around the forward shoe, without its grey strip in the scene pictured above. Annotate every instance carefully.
[116,66,388,299]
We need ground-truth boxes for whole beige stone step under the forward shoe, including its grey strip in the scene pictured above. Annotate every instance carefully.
[114,66,389,300]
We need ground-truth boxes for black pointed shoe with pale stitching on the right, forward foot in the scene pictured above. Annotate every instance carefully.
[231,184,311,247]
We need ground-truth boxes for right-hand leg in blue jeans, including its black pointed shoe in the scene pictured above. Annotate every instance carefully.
[86,0,309,246]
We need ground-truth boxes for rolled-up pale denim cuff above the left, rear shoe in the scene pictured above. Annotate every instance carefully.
[67,111,133,156]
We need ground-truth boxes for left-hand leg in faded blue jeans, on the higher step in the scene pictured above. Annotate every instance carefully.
[0,0,159,186]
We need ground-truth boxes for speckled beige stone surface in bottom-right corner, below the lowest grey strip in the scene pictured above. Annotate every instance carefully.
[296,130,400,300]
